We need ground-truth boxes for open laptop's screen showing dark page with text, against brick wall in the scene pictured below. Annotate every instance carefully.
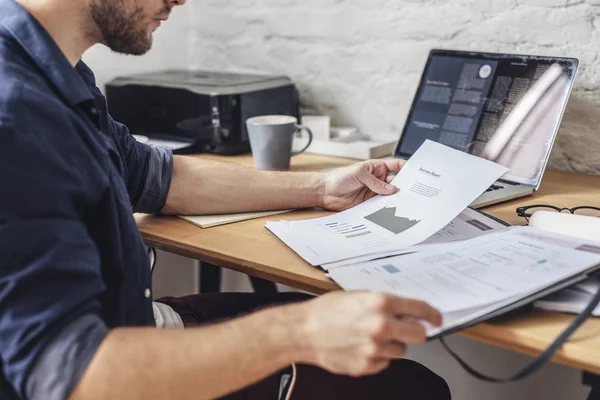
[395,50,578,186]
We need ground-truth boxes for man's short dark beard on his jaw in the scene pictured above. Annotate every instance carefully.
[90,0,152,56]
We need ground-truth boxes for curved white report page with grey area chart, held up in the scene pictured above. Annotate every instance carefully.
[266,140,507,266]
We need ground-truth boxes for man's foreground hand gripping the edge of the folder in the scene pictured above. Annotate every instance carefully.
[298,292,442,376]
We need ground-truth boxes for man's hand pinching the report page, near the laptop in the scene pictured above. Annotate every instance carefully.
[323,159,404,211]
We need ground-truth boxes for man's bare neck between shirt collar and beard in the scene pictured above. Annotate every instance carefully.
[16,0,96,66]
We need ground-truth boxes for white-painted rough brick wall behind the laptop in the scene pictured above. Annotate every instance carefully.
[186,0,600,173]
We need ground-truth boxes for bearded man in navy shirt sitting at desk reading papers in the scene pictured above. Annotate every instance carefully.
[0,0,449,399]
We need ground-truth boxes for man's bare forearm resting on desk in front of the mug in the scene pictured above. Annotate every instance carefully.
[162,156,324,215]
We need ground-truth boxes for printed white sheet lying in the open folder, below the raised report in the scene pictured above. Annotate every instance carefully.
[329,227,600,336]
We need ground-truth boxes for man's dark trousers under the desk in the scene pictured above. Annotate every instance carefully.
[158,293,450,400]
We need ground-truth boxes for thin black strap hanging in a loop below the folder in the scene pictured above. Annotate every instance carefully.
[440,284,600,383]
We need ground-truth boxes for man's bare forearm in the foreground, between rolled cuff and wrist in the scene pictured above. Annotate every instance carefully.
[71,305,302,400]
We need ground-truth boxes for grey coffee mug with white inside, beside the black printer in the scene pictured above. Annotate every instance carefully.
[246,115,313,171]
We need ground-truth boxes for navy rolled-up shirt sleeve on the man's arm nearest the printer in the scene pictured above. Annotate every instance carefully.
[109,117,173,214]
